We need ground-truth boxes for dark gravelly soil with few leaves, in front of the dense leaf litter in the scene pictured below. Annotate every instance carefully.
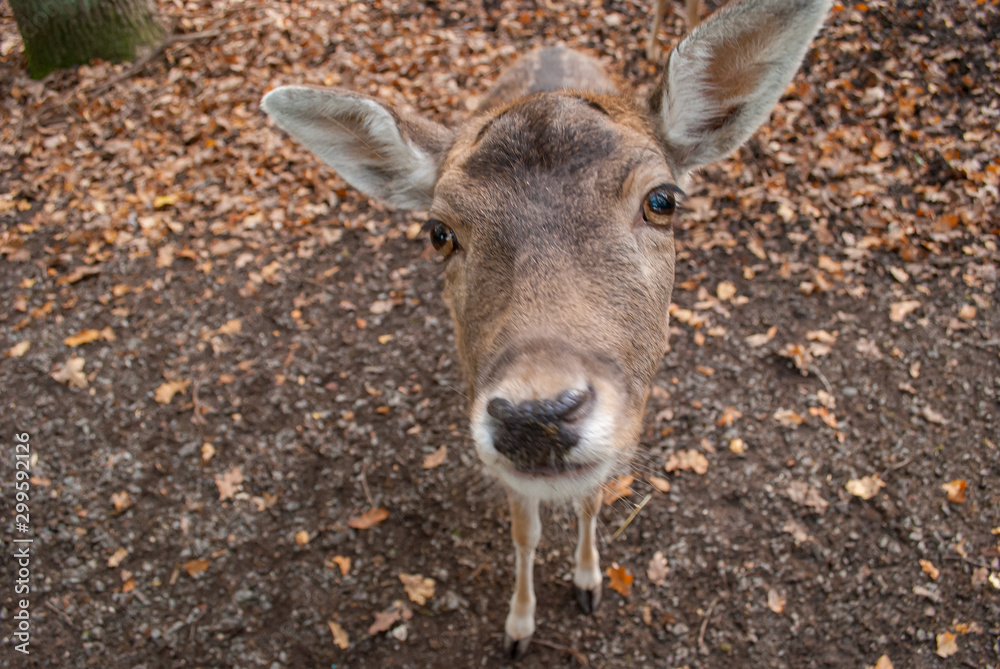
[0,1,1000,668]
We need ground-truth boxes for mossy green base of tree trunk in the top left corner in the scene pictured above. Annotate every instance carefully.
[10,0,165,79]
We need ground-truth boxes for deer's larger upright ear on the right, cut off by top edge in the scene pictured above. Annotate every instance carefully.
[650,0,831,172]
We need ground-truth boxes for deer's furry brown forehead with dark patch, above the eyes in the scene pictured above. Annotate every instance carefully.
[431,93,671,226]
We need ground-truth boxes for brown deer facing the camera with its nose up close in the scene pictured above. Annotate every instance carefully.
[261,0,832,659]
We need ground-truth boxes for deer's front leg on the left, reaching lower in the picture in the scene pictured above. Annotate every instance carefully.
[504,492,542,660]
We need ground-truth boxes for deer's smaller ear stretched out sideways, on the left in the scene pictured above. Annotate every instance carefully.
[261,86,451,209]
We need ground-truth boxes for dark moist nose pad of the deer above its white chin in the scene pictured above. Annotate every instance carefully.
[486,387,594,470]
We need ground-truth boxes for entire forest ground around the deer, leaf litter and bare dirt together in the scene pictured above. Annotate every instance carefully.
[0,0,1000,669]
